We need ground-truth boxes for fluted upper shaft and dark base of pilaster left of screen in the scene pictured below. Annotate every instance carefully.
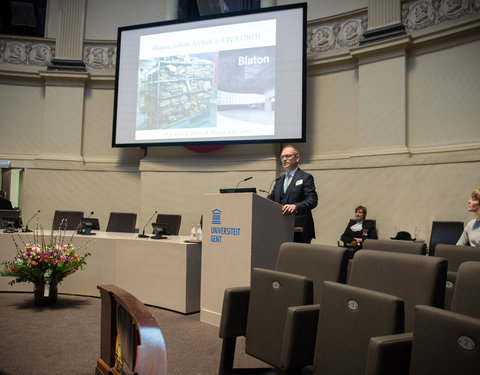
[48,0,86,71]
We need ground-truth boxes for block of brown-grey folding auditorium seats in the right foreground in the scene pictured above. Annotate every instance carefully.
[219,241,480,375]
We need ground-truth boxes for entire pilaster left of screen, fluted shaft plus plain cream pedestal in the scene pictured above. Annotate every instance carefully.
[36,0,89,162]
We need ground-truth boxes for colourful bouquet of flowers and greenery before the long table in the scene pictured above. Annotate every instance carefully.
[0,223,90,285]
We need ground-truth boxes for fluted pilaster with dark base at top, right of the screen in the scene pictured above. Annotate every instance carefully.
[360,0,405,44]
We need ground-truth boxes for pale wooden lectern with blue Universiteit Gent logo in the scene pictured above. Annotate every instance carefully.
[200,193,295,327]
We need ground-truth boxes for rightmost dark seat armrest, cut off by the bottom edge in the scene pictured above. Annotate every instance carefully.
[365,332,413,375]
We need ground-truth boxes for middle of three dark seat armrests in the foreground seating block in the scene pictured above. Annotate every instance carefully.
[281,304,320,369]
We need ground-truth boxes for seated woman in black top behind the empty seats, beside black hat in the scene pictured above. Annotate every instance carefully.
[340,206,378,250]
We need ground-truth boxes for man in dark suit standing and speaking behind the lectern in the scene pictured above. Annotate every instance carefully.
[268,145,318,243]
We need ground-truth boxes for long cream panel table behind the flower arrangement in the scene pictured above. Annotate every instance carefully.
[0,231,202,314]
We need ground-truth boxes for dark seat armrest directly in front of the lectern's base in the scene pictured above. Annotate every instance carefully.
[219,286,250,339]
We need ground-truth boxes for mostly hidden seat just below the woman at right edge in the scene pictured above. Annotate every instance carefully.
[435,244,480,309]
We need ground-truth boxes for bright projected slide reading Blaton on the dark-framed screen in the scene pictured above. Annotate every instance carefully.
[135,20,276,140]
